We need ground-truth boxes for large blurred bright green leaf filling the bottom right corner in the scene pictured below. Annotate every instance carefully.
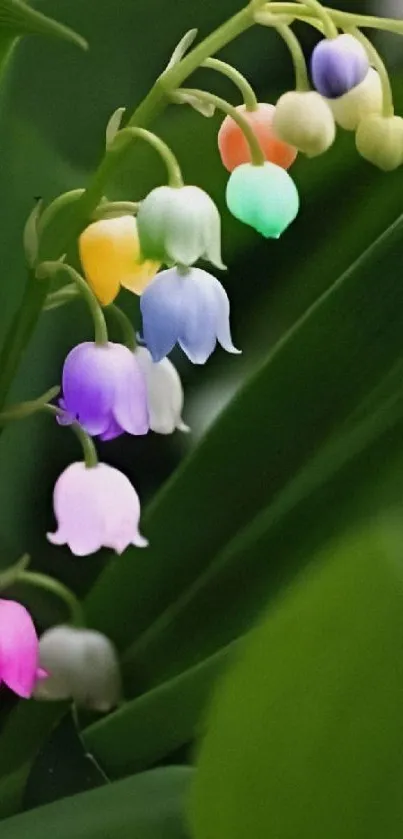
[192,523,403,839]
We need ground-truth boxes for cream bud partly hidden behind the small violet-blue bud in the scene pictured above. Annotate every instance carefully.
[327,67,383,131]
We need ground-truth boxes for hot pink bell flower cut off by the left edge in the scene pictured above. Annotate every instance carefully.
[0,600,43,699]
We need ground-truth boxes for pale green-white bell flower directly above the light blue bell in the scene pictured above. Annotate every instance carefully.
[137,186,225,268]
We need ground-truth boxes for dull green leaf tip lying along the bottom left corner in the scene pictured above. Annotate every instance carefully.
[2,767,192,839]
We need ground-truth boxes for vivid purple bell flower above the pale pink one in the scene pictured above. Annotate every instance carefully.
[60,341,149,440]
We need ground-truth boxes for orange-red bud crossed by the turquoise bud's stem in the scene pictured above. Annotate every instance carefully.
[218,102,298,172]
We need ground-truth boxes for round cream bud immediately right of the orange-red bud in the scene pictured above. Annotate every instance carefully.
[273,90,336,157]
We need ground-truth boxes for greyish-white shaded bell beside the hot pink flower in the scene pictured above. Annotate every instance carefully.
[34,626,122,712]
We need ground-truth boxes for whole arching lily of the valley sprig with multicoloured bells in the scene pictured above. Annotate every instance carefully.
[0,0,403,711]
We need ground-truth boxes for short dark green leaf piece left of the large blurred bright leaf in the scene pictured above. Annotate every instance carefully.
[83,644,235,778]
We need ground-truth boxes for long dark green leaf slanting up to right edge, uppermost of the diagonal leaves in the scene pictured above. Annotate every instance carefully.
[88,213,403,647]
